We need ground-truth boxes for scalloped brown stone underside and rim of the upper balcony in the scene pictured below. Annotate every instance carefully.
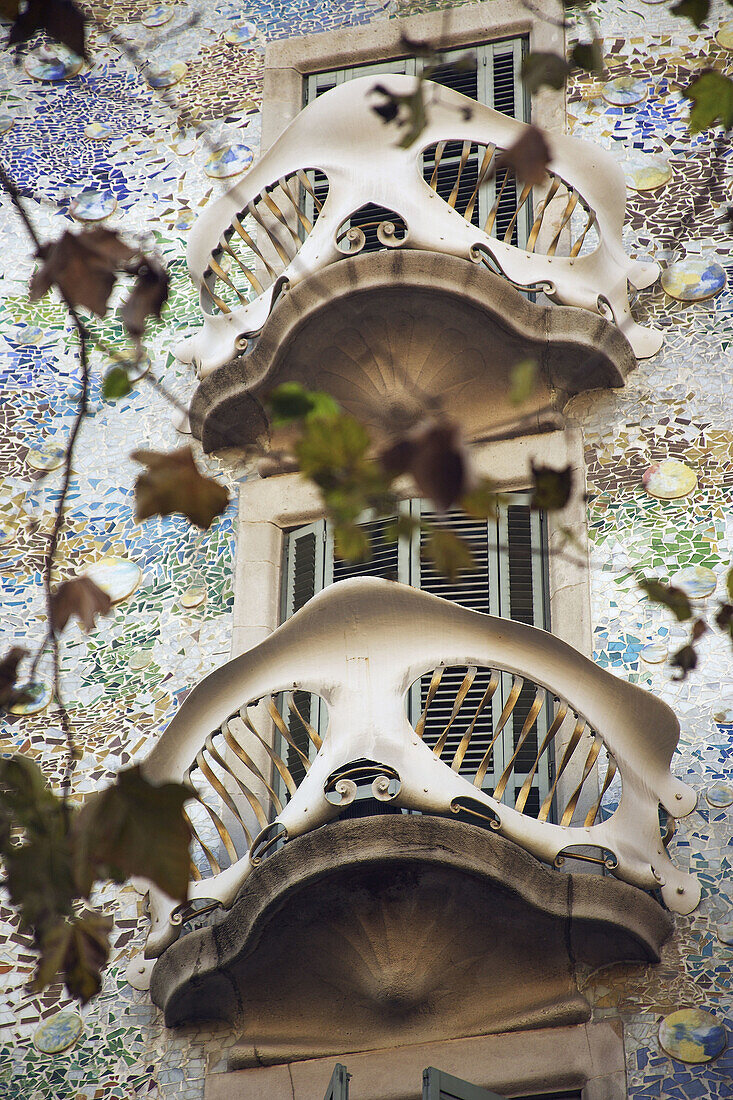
[190,250,636,451]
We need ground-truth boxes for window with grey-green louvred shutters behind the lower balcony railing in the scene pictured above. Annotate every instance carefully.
[282,493,550,815]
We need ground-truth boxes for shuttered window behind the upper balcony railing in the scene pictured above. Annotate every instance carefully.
[304,39,532,252]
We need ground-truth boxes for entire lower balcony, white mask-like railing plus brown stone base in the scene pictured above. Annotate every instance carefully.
[129,579,699,1057]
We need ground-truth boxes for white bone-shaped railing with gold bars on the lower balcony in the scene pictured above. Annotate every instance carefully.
[129,578,700,990]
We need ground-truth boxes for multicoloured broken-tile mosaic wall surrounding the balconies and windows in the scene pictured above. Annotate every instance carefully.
[0,0,733,1100]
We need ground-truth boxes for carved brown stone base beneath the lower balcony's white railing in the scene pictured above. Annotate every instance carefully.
[151,815,672,1047]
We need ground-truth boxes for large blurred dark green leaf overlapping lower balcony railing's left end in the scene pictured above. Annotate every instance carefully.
[74,767,193,901]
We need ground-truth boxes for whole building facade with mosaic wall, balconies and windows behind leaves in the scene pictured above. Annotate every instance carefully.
[0,0,733,1100]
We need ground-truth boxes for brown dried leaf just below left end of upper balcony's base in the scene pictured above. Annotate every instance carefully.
[132,447,229,530]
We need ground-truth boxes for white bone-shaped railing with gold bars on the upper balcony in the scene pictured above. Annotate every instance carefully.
[177,76,661,375]
